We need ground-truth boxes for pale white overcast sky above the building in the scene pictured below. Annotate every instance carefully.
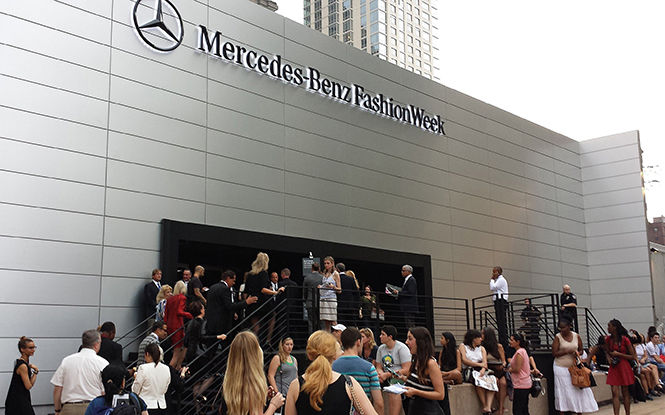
[277,0,665,219]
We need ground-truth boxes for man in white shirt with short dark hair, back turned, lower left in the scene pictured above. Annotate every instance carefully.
[51,330,109,415]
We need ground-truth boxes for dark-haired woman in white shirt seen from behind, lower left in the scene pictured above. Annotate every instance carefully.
[132,343,171,415]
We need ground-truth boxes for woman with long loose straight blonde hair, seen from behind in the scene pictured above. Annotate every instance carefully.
[222,331,284,415]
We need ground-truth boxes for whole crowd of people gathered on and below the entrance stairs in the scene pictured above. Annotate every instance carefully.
[5,253,665,415]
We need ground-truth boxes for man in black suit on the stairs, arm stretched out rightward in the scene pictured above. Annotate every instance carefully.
[206,270,258,341]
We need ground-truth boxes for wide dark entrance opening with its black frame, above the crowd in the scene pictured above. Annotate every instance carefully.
[160,219,433,330]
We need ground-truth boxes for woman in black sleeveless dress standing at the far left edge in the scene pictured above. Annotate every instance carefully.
[5,336,39,415]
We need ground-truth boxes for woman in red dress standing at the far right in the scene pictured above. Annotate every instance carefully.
[605,319,637,415]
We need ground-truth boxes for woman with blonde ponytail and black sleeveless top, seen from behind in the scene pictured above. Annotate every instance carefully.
[286,330,377,415]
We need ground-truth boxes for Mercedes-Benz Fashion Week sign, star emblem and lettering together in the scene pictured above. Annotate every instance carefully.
[132,0,445,135]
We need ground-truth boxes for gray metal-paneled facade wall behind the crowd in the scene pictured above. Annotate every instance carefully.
[0,0,653,405]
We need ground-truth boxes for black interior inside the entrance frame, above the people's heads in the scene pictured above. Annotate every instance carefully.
[177,240,425,294]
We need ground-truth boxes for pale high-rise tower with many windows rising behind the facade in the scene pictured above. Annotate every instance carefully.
[303,0,438,80]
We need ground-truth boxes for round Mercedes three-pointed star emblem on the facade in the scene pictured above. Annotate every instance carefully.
[132,0,185,52]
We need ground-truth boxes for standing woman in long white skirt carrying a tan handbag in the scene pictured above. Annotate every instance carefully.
[552,318,598,415]
